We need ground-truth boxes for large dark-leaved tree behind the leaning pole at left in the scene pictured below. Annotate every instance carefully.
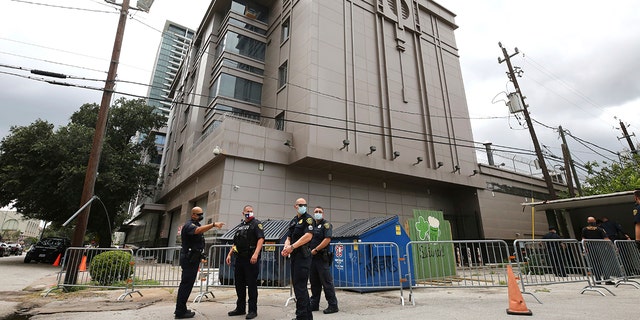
[0,98,166,247]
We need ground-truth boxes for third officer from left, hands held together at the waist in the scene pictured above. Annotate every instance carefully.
[280,198,316,320]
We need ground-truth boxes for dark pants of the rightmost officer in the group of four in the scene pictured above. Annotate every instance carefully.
[309,254,338,309]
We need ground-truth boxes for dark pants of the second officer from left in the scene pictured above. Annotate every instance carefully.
[233,255,260,313]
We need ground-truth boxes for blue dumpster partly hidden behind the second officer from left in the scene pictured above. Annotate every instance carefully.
[218,219,291,287]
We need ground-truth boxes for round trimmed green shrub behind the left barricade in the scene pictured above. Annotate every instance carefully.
[89,251,133,286]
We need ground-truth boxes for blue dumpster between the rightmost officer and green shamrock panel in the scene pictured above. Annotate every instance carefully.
[331,216,413,292]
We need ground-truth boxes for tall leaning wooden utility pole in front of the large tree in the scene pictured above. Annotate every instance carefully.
[64,0,130,284]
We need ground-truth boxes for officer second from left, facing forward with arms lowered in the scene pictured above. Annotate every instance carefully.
[226,205,264,319]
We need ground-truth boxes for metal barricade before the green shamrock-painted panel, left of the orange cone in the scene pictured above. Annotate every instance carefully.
[407,240,510,305]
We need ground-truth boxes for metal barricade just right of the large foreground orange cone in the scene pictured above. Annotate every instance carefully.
[513,239,609,302]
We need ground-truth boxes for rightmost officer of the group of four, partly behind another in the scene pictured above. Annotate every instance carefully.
[309,206,338,314]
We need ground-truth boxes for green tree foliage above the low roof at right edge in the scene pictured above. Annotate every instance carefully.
[583,154,640,195]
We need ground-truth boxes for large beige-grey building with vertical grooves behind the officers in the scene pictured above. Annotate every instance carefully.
[127,0,546,245]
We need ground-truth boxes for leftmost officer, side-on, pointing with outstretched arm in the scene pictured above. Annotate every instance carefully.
[174,207,224,319]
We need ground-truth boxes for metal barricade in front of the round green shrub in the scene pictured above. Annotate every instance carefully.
[44,247,142,300]
